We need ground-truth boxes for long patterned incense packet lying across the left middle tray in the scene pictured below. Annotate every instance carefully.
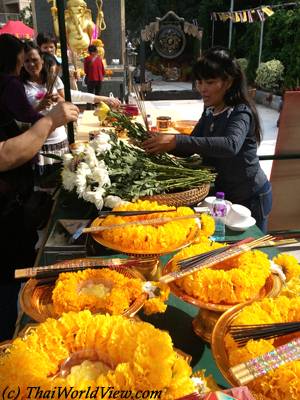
[15,258,153,279]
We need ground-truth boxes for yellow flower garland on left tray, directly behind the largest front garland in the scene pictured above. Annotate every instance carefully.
[52,268,169,315]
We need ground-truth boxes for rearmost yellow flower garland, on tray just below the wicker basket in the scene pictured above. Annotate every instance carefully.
[97,200,196,253]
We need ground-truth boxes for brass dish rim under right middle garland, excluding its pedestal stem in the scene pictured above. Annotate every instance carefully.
[162,259,282,313]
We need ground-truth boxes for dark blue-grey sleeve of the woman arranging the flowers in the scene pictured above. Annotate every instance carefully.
[176,112,251,158]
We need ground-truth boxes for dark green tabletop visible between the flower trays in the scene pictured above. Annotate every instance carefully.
[14,190,276,387]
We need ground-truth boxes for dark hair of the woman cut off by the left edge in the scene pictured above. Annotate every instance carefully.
[0,33,24,74]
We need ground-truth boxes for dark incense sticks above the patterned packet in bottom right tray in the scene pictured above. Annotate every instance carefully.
[229,322,300,346]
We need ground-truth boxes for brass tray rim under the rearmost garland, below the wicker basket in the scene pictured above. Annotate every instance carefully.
[91,218,200,256]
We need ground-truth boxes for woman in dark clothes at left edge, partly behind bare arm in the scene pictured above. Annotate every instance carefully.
[0,34,42,341]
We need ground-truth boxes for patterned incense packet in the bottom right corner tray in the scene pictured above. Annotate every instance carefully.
[229,338,300,386]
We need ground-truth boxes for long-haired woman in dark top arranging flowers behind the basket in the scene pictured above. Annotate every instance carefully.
[144,48,272,231]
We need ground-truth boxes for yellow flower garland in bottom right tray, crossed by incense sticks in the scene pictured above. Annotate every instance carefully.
[225,296,300,400]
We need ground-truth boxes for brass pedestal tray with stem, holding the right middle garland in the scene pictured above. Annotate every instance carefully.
[162,259,282,343]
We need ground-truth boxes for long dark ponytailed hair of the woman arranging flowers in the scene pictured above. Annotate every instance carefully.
[193,47,262,144]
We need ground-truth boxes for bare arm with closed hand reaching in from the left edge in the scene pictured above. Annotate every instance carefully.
[0,103,79,172]
